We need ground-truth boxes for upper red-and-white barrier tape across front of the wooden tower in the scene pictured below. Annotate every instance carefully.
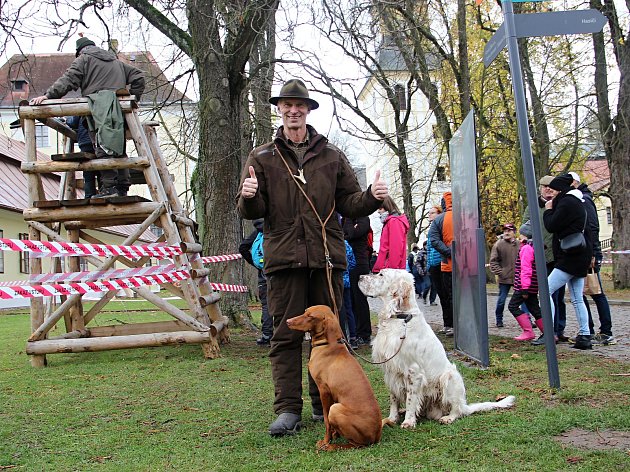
[0,238,182,259]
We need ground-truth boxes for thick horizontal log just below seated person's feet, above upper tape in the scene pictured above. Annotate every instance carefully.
[22,202,162,224]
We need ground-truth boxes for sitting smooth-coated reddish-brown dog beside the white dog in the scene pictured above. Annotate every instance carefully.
[287,305,387,451]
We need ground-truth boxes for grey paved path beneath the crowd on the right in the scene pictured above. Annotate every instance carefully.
[368,292,630,363]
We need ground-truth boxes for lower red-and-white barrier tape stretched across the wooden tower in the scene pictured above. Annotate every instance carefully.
[0,270,247,300]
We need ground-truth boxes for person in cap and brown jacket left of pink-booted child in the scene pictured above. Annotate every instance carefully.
[490,223,519,328]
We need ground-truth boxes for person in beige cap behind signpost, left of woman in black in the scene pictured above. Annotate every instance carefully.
[523,175,569,346]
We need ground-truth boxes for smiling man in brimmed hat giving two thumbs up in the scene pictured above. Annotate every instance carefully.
[237,79,388,437]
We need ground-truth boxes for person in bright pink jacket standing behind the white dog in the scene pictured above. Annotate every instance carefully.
[372,197,409,272]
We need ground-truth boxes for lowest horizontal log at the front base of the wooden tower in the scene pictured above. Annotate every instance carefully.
[26,331,212,355]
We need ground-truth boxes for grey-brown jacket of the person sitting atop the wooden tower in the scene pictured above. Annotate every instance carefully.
[46,46,144,101]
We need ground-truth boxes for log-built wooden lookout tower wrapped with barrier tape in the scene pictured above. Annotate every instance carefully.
[19,96,229,367]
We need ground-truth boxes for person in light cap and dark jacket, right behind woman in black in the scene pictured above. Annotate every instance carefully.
[569,172,617,346]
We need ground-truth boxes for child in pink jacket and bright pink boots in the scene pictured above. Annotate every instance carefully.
[508,221,543,341]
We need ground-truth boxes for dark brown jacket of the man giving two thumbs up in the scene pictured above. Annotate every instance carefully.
[237,126,381,274]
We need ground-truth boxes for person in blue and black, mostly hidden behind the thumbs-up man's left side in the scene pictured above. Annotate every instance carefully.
[238,218,273,346]
